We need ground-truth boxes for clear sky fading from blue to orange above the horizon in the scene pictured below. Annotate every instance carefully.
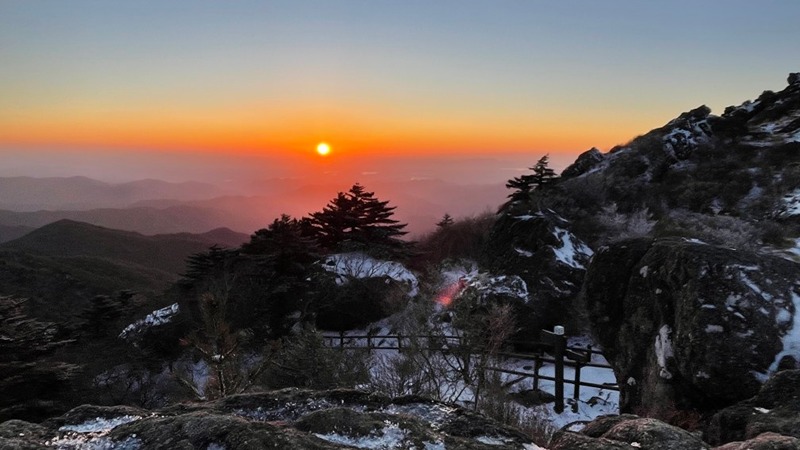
[0,0,800,168]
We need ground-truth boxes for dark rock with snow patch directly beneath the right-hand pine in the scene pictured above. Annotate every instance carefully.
[486,210,592,337]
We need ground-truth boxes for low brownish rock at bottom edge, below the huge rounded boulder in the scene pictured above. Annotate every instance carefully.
[548,415,710,450]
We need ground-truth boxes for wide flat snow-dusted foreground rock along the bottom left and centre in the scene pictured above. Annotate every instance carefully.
[0,389,535,450]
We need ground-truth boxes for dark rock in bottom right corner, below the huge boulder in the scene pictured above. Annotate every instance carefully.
[706,370,800,450]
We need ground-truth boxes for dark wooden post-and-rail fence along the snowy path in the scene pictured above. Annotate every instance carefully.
[324,330,619,413]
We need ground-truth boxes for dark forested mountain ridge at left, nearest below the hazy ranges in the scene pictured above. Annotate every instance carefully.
[0,220,249,304]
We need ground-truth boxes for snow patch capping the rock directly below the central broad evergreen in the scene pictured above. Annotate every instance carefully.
[322,253,419,297]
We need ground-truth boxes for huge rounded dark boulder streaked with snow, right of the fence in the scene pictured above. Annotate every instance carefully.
[584,238,800,417]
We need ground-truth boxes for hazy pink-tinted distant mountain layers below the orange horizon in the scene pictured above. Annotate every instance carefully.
[0,177,507,237]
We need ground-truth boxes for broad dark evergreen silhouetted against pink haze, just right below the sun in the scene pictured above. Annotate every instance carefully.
[305,183,410,257]
